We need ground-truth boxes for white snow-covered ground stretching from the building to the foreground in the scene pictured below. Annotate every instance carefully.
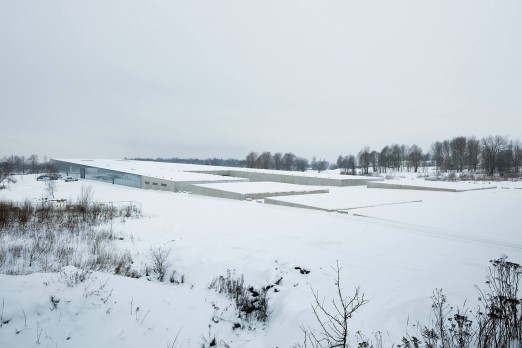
[0,176,522,347]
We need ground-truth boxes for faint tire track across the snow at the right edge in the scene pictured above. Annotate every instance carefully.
[353,214,522,251]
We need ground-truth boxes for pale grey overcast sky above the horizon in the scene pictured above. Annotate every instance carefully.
[0,0,522,161]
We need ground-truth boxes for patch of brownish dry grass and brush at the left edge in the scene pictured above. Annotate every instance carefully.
[0,200,141,277]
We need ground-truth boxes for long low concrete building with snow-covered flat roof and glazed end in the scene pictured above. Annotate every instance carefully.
[52,159,379,199]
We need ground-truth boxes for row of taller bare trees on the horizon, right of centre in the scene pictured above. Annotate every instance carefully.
[245,135,522,177]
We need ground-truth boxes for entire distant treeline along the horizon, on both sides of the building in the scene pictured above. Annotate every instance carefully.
[0,135,522,186]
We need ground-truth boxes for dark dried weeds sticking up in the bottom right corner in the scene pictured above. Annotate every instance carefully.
[384,256,522,348]
